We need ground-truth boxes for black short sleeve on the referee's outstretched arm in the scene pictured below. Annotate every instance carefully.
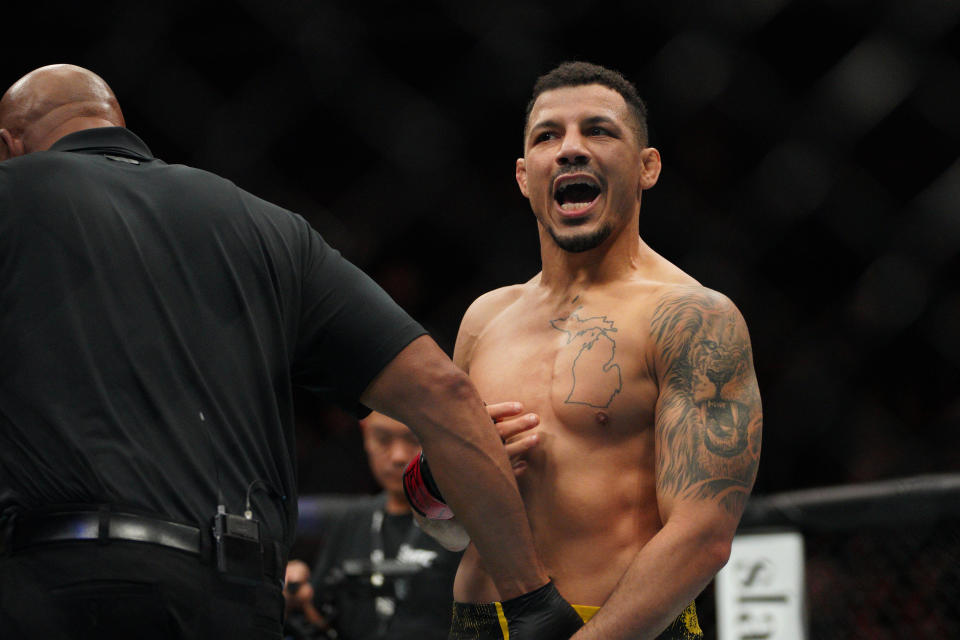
[293,223,426,416]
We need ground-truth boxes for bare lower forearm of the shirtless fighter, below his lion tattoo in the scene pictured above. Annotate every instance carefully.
[572,525,729,640]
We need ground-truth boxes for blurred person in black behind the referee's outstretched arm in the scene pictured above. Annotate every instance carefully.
[291,412,460,640]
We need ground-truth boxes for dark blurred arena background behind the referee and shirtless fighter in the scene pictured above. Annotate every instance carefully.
[0,0,960,494]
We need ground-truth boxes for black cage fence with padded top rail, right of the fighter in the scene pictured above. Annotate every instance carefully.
[698,475,960,640]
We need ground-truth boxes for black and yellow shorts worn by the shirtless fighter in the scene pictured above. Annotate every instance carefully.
[448,602,703,640]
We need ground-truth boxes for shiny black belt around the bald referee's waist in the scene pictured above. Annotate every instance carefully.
[0,507,285,580]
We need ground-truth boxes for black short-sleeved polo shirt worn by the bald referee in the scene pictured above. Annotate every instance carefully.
[0,128,424,546]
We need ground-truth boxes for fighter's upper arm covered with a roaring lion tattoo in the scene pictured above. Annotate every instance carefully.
[651,287,763,519]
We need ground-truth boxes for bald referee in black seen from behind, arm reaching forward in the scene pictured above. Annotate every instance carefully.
[0,65,569,640]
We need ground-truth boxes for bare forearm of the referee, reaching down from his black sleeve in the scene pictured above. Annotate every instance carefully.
[362,337,548,599]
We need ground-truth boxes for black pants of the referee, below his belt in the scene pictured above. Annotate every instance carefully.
[0,541,283,640]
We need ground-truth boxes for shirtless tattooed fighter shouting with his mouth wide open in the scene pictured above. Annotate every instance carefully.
[406,63,762,640]
